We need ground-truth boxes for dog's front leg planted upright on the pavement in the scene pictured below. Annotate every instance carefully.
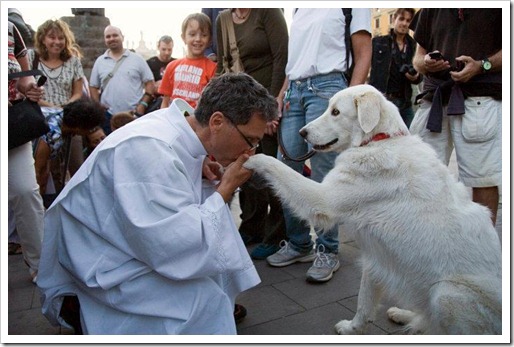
[335,270,380,335]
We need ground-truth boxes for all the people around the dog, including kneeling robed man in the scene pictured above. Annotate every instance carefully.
[8,8,502,334]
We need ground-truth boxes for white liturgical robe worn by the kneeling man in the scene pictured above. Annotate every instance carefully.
[37,102,260,334]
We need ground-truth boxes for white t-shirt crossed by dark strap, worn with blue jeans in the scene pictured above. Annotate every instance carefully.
[286,8,371,80]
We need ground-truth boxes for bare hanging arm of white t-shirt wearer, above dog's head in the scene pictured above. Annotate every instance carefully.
[350,30,372,86]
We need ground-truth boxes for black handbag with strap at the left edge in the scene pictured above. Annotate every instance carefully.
[8,70,50,149]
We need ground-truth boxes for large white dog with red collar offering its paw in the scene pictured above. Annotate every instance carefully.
[245,85,502,334]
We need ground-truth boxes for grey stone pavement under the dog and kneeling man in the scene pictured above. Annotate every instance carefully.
[6,154,502,342]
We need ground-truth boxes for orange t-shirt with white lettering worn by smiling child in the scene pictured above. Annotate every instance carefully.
[159,57,216,108]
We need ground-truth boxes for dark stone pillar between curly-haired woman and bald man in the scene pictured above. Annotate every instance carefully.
[61,8,111,80]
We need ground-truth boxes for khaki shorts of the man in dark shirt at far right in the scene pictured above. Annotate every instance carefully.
[410,97,502,188]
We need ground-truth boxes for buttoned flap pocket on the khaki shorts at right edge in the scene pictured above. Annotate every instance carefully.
[462,97,501,142]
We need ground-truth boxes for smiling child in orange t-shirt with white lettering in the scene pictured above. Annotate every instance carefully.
[159,13,216,108]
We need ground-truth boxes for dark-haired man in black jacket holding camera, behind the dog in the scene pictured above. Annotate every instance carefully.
[369,8,422,127]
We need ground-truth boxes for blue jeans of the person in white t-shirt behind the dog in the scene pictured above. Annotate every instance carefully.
[277,72,348,253]
